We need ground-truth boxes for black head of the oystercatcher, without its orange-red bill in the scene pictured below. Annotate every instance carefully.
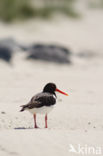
[43,83,56,94]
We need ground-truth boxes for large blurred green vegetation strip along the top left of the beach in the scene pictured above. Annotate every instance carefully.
[0,0,78,22]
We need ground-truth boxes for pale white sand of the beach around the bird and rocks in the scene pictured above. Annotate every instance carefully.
[0,3,103,156]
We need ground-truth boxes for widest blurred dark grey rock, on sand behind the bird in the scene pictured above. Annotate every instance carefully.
[27,44,71,63]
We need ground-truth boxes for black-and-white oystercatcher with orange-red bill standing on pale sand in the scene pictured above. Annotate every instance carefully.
[20,83,68,128]
